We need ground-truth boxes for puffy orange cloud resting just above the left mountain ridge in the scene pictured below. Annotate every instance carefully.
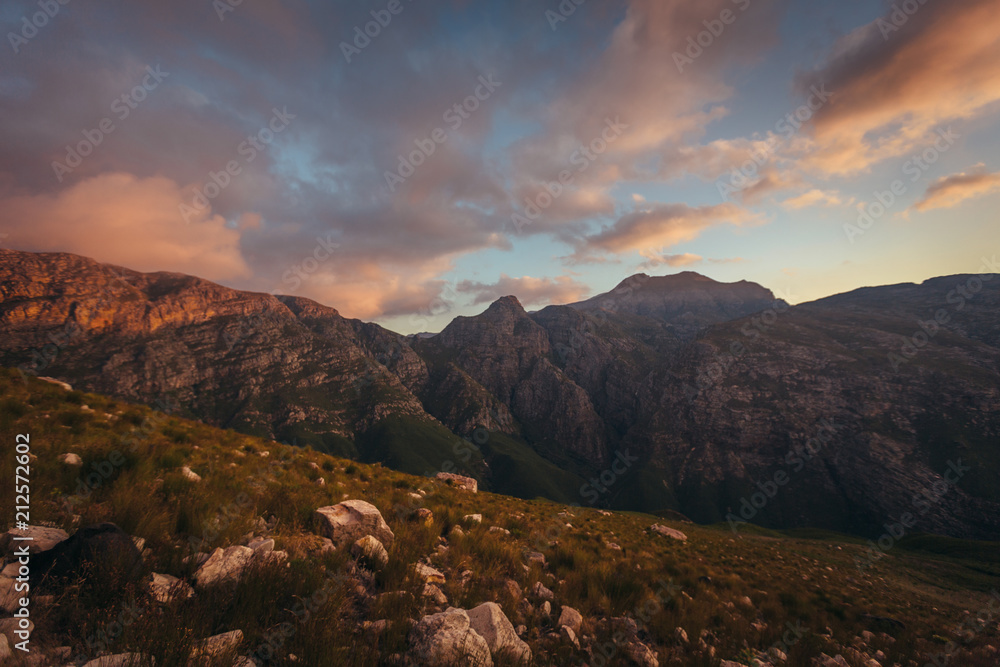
[0,173,252,280]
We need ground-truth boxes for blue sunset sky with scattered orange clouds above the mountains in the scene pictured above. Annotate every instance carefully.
[0,0,1000,333]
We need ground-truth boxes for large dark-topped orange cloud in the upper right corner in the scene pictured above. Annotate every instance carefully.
[800,0,1000,175]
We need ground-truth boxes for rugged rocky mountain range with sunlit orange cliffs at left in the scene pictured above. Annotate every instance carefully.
[0,251,1000,539]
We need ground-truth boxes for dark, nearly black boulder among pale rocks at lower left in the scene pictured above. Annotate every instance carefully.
[31,523,142,593]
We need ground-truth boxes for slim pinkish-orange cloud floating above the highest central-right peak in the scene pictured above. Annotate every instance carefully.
[577,203,764,259]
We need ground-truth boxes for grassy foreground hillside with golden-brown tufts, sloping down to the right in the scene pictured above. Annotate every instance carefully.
[0,370,1000,667]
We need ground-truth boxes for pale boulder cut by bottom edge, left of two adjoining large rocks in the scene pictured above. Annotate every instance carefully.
[409,607,493,667]
